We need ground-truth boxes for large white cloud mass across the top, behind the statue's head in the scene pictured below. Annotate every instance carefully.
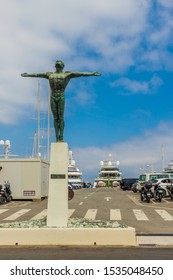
[0,0,173,123]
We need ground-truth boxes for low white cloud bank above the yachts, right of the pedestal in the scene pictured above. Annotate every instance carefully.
[73,122,173,180]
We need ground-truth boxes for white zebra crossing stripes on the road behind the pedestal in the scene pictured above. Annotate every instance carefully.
[0,208,173,222]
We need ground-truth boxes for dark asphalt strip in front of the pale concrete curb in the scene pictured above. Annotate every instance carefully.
[0,246,173,260]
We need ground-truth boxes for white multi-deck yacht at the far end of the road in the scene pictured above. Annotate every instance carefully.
[93,154,122,187]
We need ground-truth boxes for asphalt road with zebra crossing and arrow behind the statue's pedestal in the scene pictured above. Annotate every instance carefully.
[0,188,173,234]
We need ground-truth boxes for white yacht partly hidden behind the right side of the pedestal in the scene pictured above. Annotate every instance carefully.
[68,150,83,188]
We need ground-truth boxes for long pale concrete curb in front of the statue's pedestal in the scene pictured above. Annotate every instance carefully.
[0,227,137,246]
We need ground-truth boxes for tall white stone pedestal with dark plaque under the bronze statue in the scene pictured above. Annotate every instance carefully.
[47,142,68,227]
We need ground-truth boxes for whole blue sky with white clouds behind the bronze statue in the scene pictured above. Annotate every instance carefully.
[0,0,173,180]
